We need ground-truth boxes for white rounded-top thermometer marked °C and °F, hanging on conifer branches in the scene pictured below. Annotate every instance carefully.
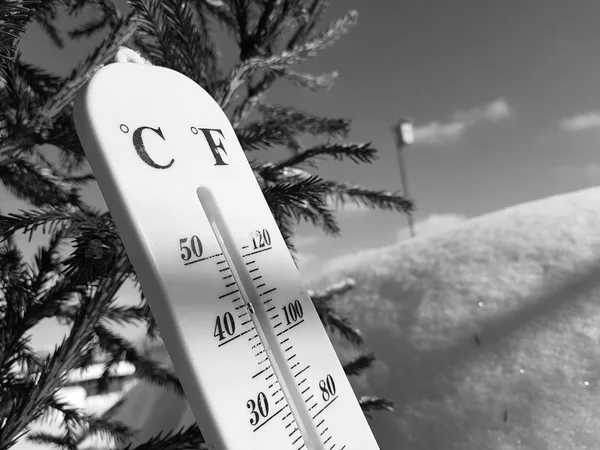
[75,63,378,450]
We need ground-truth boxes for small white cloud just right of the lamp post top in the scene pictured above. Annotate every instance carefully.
[414,98,513,145]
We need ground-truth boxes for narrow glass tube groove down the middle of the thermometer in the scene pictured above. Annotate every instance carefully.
[196,186,325,450]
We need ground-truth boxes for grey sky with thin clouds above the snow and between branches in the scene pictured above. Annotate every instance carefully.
[0,0,600,345]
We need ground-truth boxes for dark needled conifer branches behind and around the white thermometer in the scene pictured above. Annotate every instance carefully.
[0,0,412,450]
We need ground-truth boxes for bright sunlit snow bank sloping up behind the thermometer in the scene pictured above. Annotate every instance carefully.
[10,188,600,450]
